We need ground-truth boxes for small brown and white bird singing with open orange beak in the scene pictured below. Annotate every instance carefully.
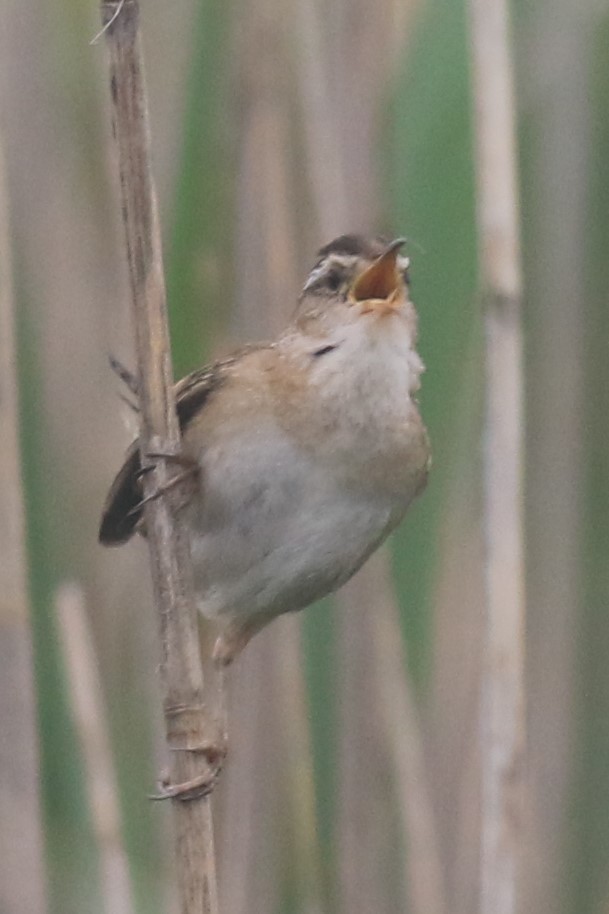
[99,235,431,666]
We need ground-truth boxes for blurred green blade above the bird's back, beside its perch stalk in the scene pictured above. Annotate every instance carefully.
[166,0,234,377]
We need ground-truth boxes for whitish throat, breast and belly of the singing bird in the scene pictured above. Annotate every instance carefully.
[191,310,424,618]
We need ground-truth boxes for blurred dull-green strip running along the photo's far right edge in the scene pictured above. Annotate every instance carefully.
[561,13,609,914]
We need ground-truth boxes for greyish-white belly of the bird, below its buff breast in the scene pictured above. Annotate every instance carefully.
[190,429,416,619]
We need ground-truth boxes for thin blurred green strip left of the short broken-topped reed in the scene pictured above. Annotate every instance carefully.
[17,278,101,914]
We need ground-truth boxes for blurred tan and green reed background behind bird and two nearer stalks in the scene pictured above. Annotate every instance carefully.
[0,0,609,914]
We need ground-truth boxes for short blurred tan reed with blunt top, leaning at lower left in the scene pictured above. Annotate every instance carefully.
[55,584,134,914]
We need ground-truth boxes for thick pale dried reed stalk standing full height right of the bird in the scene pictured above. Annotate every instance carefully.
[470,0,525,914]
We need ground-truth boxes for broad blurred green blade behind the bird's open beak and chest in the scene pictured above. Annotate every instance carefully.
[385,0,477,685]
